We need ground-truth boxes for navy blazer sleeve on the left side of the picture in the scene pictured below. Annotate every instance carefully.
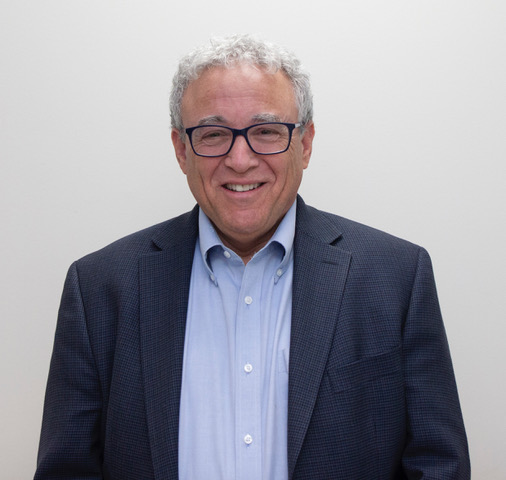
[34,264,103,480]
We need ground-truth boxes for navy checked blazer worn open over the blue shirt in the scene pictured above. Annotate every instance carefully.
[35,197,470,480]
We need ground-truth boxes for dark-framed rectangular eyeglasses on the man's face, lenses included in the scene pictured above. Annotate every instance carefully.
[185,122,301,157]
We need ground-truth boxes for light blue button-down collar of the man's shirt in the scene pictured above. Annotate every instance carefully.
[199,200,297,274]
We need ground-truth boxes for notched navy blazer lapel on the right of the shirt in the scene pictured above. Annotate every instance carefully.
[288,197,351,478]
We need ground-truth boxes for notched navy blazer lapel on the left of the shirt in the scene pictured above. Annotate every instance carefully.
[139,209,198,479]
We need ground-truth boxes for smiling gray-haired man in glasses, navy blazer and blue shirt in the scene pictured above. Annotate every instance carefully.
[35,36,469,480]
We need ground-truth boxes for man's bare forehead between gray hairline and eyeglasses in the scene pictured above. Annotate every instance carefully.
[181,64,297,126]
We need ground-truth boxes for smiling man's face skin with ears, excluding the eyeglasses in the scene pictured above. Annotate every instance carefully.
[172,65,314,256]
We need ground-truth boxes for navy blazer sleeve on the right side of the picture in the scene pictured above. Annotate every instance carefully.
[402,249,470,480]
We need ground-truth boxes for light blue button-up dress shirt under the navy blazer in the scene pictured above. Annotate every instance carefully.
[179,203,295,480]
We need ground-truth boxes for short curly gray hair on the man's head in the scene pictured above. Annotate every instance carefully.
[170,35,313,134]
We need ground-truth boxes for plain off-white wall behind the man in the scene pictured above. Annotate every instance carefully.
[0,0,506,480]
